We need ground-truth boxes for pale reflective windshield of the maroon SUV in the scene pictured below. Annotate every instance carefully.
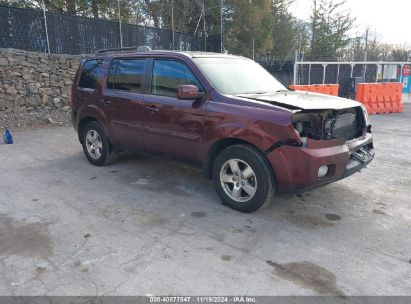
[193,57,286,95]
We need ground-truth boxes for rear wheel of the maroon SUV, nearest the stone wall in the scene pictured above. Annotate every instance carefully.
[81,121,118,166]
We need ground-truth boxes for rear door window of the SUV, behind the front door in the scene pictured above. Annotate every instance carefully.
[107,59,145,93]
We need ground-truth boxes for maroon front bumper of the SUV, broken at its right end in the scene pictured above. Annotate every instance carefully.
[267,133,375,192]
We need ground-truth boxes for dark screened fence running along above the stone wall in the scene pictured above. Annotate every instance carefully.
[0,6,204,54]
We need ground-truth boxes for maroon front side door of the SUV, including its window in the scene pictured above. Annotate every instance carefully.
[144,59,206,163]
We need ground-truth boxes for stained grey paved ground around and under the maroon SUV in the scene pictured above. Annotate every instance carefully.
[0,105,411,303]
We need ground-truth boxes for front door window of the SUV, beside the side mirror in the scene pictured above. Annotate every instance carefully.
[151,60,204,97]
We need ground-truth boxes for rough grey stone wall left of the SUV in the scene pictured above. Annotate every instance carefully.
[0,49,82,113]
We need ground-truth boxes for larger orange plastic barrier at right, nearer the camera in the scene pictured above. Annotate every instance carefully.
[355,82,403,114]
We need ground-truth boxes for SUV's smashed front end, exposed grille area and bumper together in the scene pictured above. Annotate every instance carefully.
[267,106,374,191]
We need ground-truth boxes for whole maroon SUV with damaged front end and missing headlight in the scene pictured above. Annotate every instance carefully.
[72,51,374,212]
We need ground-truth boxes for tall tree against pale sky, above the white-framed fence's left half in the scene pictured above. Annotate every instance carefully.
[310,0,354,60]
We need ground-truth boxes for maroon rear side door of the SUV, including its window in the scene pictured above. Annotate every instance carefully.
[100,58,147,151]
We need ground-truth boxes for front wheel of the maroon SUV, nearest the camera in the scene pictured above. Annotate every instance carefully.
[213,144,275,212]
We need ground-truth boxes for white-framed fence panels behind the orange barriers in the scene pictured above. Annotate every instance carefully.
[293,62,411,98]
